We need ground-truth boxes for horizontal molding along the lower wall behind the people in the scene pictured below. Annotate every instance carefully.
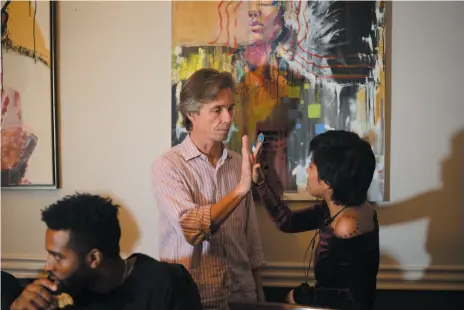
[1,254,464,291]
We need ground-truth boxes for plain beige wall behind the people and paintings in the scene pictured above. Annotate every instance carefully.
[1,1,464,289]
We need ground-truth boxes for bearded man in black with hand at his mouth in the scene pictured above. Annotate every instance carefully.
[11,194,201,310]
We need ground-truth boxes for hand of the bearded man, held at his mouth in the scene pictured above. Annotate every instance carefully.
[10,278,56,310]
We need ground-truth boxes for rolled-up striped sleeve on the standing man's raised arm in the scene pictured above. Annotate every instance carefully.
[151,157,211,245]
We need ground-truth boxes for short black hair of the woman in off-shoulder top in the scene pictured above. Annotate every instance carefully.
[309,130,376,206]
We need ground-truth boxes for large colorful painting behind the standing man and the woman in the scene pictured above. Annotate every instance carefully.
[171,1,389,201]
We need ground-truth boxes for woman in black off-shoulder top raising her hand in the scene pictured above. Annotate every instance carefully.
[253,130,379,310]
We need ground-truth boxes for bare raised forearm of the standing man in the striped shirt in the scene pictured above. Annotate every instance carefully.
[211,185,248,228]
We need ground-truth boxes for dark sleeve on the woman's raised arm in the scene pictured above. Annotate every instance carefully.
[256,181,326,233]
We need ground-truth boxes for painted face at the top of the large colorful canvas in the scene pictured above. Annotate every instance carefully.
[248,1,282,44]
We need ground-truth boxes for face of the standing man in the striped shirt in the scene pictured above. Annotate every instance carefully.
[188,88,235,142]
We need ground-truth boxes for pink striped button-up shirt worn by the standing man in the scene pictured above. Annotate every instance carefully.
[152,136,264,310]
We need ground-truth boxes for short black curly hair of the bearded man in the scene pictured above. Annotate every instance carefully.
[42,193,121,258]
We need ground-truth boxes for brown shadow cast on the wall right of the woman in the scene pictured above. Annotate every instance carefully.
[377,130,464,274]
